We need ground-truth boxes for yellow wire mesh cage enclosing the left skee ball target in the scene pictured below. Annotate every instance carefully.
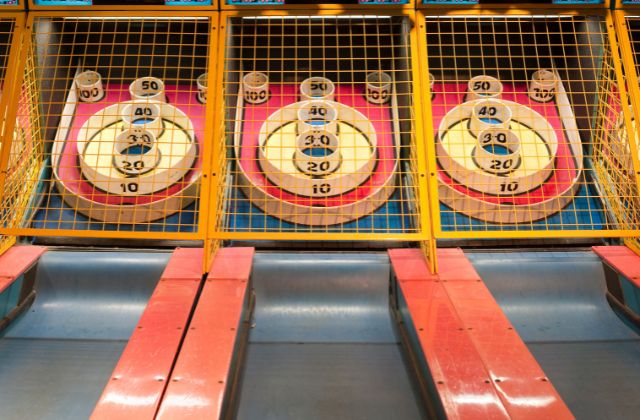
[0,14,213,239]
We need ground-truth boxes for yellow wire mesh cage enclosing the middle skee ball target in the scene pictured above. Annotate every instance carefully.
[212,15,429,240]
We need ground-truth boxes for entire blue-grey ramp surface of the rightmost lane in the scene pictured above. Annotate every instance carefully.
[467,251,640,419]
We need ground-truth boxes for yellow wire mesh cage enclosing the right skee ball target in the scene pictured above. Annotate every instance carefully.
[422,12,639,237]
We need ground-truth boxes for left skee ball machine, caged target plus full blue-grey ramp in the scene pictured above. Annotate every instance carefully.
[0,1,218,418]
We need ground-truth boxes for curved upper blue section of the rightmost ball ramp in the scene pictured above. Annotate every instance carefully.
[467,252,638,342]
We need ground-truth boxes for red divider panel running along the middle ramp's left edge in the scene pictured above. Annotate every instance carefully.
[157,248,253,419]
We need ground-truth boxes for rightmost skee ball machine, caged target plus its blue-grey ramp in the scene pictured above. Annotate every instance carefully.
[416,0,640,418]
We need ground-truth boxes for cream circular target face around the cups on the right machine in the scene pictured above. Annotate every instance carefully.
[436,100,558,196]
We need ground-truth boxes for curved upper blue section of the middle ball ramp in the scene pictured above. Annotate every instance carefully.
[251,252,397,343]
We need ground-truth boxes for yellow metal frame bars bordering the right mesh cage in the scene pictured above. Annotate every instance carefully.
[417,5,640,239]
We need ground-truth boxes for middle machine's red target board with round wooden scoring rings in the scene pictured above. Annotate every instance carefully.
[234,76,399,226]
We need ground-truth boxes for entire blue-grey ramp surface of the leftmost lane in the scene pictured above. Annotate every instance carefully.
[0,251,171,420]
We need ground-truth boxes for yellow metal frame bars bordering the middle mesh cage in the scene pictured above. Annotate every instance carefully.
[208,8,435,269]
